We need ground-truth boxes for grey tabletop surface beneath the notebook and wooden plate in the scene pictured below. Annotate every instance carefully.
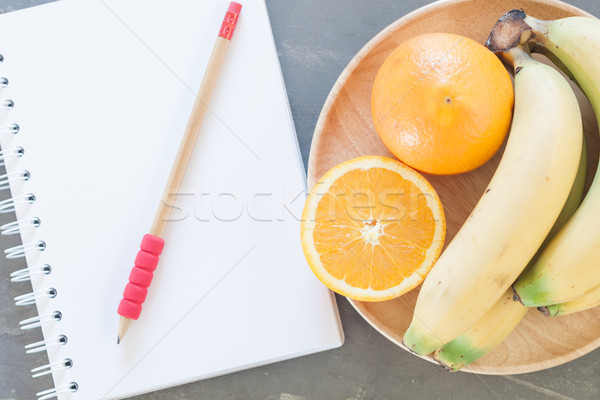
[0,0,600,400]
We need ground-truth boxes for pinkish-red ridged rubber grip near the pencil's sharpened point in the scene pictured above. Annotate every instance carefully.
[117,235,165,319]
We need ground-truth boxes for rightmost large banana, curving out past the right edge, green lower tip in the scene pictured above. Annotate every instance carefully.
[510,10,600,307]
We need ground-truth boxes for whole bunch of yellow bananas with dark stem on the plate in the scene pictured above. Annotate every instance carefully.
[404,10,600,371]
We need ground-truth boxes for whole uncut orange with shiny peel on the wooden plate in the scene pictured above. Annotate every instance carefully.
[371,33,514,175]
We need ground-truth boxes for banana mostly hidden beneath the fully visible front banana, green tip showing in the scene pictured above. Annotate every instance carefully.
[433,136,584,371]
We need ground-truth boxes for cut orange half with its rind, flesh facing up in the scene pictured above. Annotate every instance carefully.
[301,156,446,301]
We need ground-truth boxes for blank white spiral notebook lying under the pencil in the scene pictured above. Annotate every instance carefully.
[0,0,343,400]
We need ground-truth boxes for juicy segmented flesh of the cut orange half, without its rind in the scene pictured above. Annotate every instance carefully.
[313,168,436,290]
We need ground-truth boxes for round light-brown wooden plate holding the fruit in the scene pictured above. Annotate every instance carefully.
[308,0,600,374]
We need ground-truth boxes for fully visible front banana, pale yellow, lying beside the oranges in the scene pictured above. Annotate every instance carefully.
[403,41,582,355]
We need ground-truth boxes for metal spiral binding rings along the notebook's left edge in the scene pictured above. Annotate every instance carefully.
[0,54,79,400]
